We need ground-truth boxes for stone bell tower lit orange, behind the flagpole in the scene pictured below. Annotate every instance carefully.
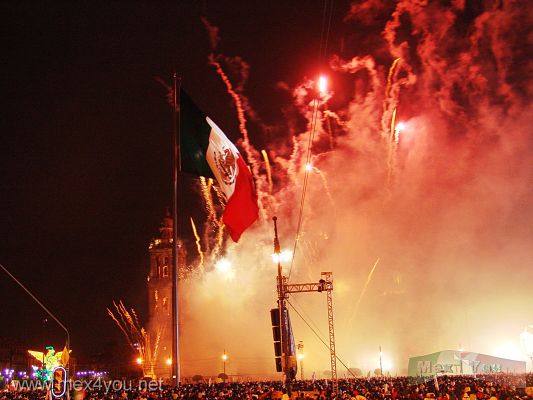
[147,210,186,379]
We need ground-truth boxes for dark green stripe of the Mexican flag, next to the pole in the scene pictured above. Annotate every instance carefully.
[180,90,214,178]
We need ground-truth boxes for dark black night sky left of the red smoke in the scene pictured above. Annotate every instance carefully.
[0,1,344,354]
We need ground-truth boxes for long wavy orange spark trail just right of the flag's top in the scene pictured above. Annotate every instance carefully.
[209,54,268,220]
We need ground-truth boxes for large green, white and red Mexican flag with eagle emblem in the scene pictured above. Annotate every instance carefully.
[180,90,259,242]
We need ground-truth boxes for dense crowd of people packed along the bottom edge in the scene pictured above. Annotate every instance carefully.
[0,374,533,400]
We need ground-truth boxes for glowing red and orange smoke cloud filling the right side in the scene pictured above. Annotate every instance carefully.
[177,0,533,378]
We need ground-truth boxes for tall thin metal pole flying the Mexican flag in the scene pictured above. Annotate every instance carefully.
[172,72,181,386]
